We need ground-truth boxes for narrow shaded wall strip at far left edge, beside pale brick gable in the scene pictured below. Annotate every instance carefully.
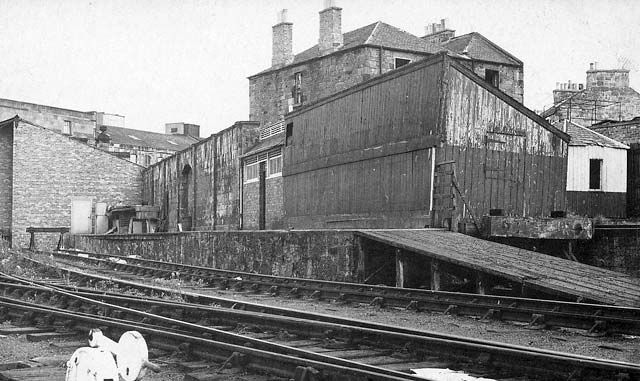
[0,124,13,234]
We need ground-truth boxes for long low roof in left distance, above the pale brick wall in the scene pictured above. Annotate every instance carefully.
[106,127,200,151]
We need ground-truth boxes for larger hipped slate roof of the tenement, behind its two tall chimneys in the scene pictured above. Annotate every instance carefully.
[253,21,442,76]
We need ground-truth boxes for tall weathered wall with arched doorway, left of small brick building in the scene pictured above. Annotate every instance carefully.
[144,122,258,231]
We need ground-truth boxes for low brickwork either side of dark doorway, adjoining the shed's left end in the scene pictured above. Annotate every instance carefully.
[242,176,286,230]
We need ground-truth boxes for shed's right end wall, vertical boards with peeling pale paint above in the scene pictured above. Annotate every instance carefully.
[435,60,568,219]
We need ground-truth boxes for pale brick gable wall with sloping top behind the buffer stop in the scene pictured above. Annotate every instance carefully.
[12,121,143,248]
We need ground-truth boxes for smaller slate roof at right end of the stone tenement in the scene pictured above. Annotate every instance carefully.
[443,32,522,66]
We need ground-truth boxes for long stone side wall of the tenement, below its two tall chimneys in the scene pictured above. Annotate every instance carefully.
[249,47,425,124]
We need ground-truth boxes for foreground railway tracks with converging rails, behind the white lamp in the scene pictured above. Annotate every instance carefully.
[0,270,640,380]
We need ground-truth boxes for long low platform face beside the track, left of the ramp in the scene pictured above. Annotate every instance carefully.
[70,230,364,282]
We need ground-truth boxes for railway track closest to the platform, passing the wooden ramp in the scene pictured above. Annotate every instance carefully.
[52,250,640,335]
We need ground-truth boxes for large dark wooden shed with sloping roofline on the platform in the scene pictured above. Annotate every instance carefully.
[283,53,569,228]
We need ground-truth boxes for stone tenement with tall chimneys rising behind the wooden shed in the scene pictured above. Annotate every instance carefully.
[249,1,524,125]
